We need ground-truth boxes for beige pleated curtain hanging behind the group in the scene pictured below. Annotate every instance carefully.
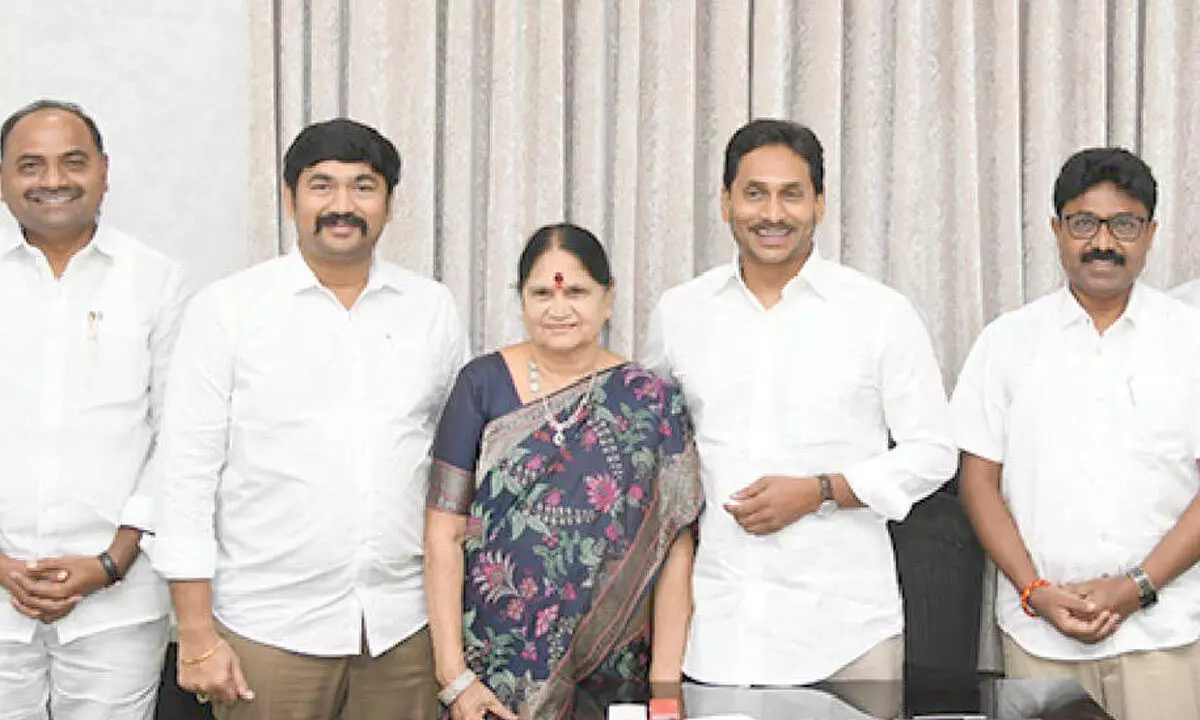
[251,0,1200,666]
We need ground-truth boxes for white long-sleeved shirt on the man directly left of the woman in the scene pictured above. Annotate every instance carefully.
[155,252,467,655]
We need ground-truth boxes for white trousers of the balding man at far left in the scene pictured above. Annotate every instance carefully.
[0,618,168,720]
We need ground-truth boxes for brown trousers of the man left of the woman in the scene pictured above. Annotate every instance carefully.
[212,626,438,720]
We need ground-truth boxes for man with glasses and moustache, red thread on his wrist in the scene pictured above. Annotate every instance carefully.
[952,148,1200,720]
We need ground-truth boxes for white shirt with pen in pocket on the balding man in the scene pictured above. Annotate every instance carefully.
[0,226,184,642]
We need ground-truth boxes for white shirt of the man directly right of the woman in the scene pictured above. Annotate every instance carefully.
[646,251,956,685]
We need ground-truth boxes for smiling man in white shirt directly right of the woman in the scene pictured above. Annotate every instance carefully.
[644,120,955,685]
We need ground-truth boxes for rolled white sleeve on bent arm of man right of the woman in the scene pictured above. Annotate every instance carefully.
[842,295,958,521]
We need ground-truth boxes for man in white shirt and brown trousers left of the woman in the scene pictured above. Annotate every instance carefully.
[155,119,467,720]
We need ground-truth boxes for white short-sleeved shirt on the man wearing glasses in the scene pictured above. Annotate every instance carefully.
[952,283,1200,660]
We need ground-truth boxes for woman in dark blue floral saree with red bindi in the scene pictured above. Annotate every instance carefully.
[426,224,703,720]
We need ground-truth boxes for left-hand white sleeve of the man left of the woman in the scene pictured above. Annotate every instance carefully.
[154,288,234,580]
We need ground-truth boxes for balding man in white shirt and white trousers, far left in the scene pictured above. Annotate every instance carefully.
[0,101,182,720]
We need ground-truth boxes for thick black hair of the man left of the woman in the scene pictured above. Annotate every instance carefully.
[283,118,400,193]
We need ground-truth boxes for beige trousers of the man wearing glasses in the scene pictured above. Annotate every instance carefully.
[1003,635,1200,720]
